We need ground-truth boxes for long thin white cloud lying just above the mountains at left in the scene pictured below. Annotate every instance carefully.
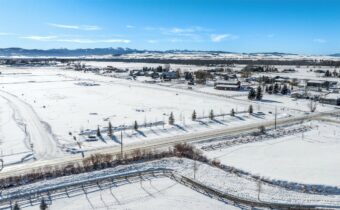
[21,36,131,44]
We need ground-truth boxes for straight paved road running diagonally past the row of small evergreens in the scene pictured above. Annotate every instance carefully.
[0,107,340,178]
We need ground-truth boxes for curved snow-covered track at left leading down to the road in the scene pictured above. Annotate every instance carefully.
[0,90,62,160]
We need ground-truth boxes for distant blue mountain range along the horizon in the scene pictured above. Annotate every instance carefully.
[0,47,334,57]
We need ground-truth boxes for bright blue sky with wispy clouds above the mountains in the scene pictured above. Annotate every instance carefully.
[0,0,340,54]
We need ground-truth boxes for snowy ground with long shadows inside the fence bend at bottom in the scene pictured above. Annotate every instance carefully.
[23,178,238,210]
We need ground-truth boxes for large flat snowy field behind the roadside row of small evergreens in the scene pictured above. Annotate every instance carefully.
[0,67,284,166]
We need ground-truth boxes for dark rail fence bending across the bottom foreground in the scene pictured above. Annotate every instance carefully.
[0,168,340,209]
